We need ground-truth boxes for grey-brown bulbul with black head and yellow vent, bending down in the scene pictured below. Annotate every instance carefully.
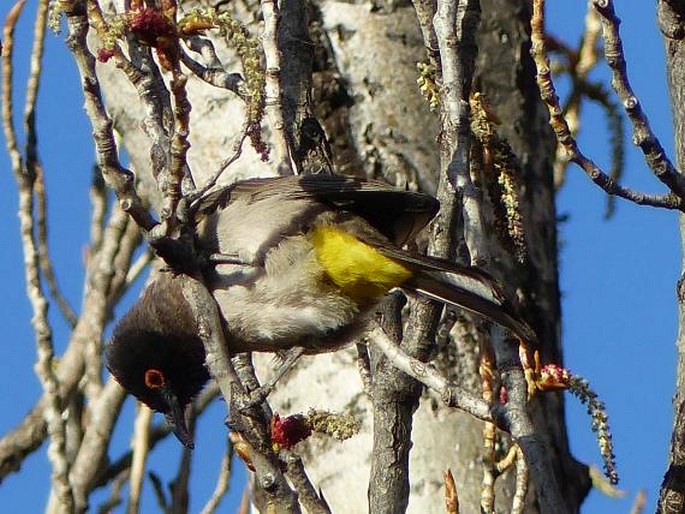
[106,175,535,446]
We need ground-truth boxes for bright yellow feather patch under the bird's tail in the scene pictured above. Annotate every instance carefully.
[309,226,412,303]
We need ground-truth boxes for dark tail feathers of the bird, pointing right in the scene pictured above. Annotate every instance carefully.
[404,270,537,342]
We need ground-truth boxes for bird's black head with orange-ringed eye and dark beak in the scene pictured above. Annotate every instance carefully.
[106,273,209,448]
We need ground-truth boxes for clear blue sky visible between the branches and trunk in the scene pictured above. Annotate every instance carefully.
[0,1,680,514]
